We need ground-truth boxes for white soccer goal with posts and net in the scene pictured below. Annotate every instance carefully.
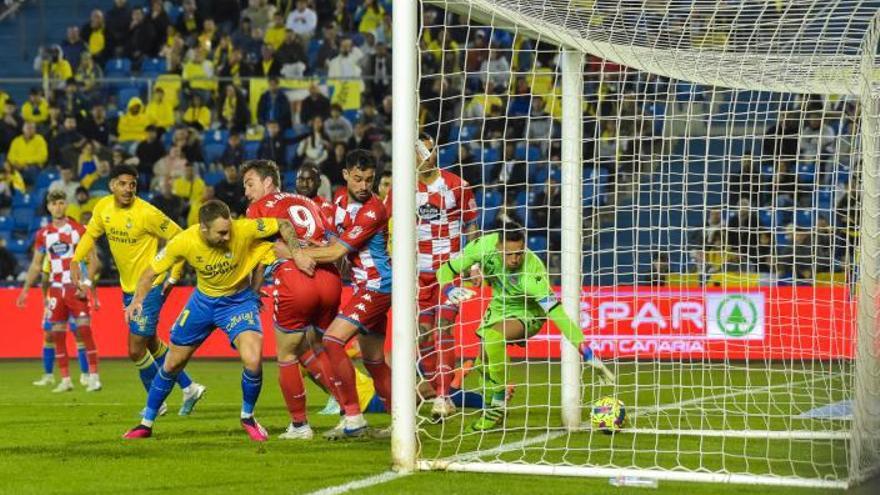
[393,0,880,487]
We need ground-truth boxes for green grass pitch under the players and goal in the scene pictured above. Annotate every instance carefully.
[0,359,876,495]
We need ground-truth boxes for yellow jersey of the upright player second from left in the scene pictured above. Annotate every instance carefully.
[73,196,182,294]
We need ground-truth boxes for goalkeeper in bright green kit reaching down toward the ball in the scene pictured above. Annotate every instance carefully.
[437,224,614,431]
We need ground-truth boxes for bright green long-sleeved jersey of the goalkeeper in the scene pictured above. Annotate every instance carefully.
[437,234,583,345]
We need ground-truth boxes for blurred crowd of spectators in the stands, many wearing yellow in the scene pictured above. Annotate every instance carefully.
[0,0,858,283]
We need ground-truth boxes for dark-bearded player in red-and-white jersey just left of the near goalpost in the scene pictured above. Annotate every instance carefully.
[279,150,391,439]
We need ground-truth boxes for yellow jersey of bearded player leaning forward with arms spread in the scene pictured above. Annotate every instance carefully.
[151,218,278,297]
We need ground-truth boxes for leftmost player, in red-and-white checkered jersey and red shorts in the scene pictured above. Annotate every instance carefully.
[16,190,101,392]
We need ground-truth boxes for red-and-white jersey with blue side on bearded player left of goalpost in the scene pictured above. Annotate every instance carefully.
[334,194,391,294]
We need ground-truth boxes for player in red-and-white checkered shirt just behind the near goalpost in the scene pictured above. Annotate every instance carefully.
[385,133,477,419]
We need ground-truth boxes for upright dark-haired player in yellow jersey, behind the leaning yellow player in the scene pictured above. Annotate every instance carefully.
[70,165,205,416]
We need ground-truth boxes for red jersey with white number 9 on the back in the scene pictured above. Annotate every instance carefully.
[247,192,333,247]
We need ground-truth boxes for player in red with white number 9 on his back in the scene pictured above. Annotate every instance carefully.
[242,160,342,440]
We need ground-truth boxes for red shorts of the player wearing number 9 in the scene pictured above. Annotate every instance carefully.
[272,261,342,332]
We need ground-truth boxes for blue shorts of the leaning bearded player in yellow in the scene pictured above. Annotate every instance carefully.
[171,288,263,348]
